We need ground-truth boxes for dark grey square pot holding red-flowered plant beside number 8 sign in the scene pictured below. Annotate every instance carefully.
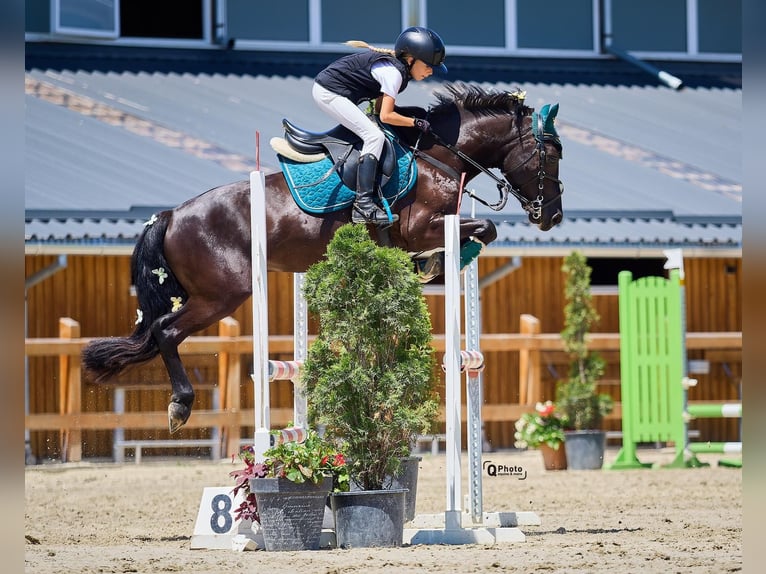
[250,476,332,551]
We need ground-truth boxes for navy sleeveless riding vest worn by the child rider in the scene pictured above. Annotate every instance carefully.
[315,50,410,104]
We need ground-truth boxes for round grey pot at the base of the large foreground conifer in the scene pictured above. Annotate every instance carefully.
[330,488,407,548]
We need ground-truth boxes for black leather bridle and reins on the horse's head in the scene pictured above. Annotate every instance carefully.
[411,108,564,221]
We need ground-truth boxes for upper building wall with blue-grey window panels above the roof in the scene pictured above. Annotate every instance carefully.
[25,0,742,59]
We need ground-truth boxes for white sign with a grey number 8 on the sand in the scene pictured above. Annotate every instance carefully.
[191,486,254,550]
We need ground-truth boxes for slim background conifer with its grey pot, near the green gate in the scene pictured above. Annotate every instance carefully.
[556,251,613,470]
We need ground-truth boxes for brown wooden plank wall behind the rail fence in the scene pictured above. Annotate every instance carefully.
[26,256,742,459]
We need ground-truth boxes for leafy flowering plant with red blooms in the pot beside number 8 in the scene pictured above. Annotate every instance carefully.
[229,429,349,522]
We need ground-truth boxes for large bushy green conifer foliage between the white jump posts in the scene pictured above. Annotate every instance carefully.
[301,225,438,490]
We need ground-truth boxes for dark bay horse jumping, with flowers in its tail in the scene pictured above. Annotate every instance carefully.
[83,84,563,432]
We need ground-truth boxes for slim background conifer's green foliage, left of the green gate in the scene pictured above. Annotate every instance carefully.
[556,251,613,430]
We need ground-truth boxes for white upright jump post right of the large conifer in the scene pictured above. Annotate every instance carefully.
[443,215,462,530]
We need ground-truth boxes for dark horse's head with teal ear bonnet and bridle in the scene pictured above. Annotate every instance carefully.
[502,104,564,231]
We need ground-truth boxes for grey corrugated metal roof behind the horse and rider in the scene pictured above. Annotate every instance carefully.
[25,48,742,255]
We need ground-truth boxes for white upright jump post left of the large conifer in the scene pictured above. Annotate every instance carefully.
[250,164,271,462]
